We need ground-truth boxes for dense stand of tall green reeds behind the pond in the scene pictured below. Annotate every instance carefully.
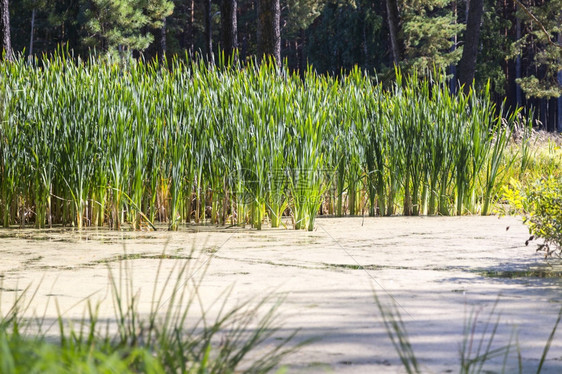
[0,55,514,230]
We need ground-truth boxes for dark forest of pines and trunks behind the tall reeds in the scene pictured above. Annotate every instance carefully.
[0,0,562,132]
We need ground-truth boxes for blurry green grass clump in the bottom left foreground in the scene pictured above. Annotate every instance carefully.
[0,250,300,374]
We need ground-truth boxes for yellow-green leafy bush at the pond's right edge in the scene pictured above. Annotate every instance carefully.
[504,176,562,257]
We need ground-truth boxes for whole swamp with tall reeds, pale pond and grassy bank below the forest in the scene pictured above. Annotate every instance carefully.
[0,50,562,373]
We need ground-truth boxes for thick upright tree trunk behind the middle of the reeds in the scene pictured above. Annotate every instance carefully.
[258,0,281,66]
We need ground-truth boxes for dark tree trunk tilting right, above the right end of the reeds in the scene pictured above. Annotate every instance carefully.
[457,0,484,92]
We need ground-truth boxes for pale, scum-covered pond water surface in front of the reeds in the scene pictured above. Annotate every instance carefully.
[0,216,562,373]
